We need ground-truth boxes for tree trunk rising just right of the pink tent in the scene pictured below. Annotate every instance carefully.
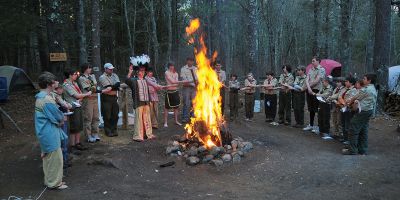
[340,0,351,76]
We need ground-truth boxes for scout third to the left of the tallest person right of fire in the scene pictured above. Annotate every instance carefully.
[263,72,278,122]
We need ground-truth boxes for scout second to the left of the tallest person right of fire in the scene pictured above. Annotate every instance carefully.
[278,65,294,125]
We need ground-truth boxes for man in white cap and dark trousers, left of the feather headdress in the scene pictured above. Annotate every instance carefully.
[99,63,120,137]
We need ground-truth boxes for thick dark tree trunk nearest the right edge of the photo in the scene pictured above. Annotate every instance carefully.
[373,0,391,111]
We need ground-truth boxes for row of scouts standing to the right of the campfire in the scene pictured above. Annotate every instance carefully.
[229,57,376,154]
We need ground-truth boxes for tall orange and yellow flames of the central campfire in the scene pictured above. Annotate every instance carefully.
[185,18,223,148]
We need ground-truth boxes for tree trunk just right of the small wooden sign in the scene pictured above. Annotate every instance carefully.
[76,0,88,65]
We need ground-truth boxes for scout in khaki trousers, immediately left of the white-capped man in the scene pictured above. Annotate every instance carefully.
[78,63,111,142]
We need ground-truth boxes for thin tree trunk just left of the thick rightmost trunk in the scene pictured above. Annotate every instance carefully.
[365,0,375,72]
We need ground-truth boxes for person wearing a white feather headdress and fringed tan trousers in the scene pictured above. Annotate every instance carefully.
[126,55,155,142]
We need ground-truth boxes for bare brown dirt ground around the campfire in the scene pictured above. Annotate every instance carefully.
[0,91,400,200]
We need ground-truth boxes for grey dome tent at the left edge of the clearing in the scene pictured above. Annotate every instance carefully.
[0,65,35,94]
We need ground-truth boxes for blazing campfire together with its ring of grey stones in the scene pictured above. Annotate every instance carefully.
[166,19,253,166]
